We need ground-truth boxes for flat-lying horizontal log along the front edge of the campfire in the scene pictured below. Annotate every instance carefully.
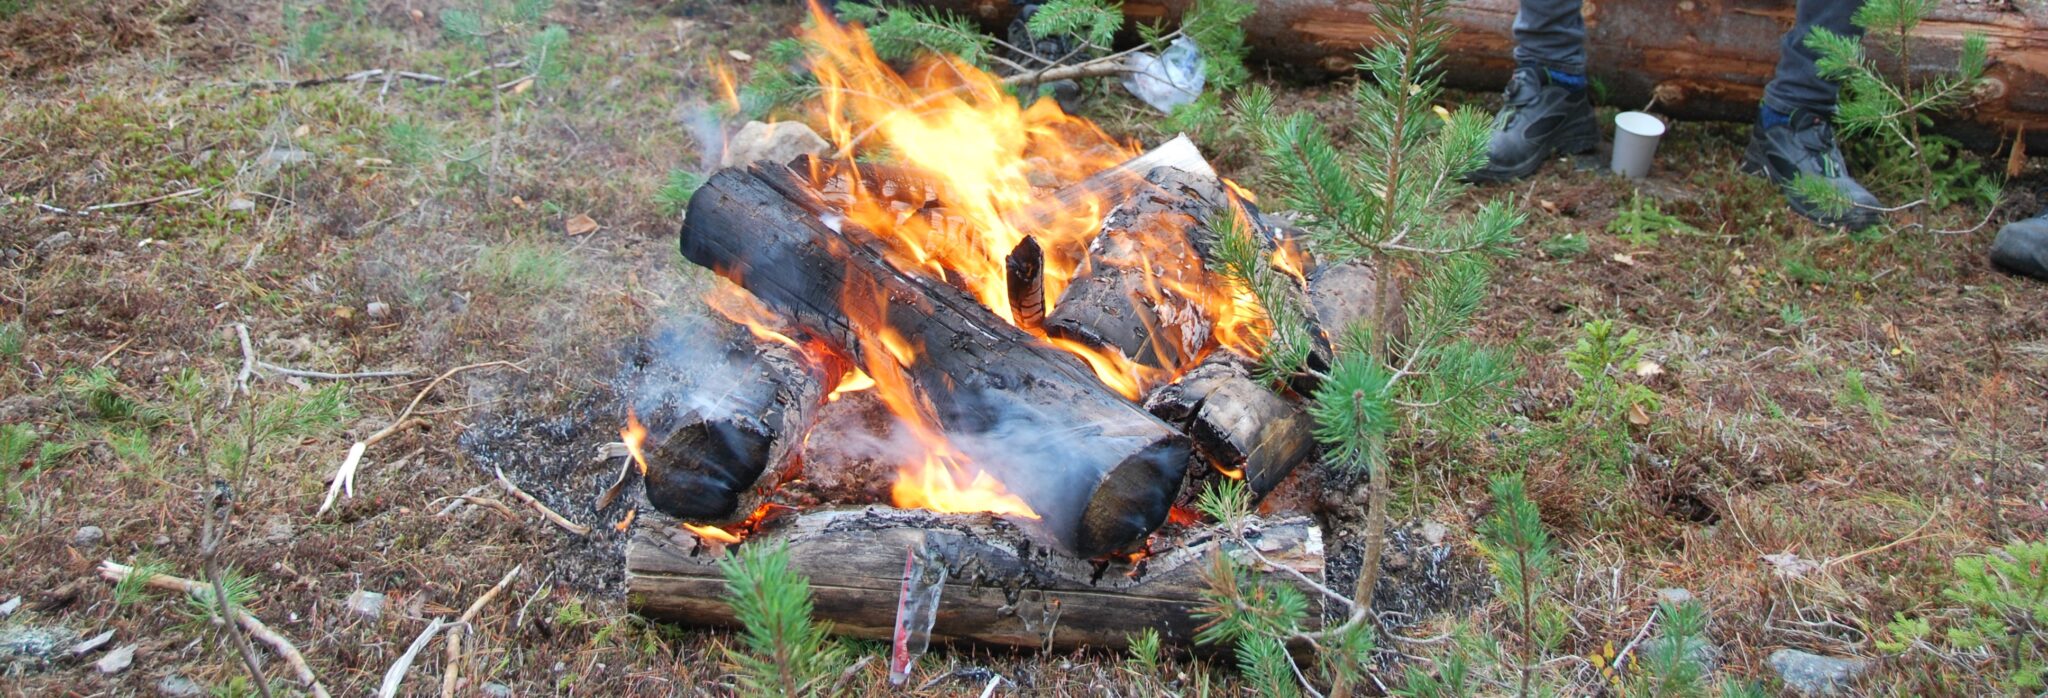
[627,508,1323,649]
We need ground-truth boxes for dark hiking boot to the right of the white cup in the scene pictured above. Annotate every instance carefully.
[1743,111,1878,231]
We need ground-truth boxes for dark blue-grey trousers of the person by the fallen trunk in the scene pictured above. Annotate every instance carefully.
[1516,0,1864,113]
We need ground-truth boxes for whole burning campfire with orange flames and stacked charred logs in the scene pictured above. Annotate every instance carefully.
[621,10,1374,645]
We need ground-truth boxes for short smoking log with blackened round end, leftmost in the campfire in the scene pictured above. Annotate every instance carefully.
[625,317,844,524]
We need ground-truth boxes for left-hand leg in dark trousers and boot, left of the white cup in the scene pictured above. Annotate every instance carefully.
[1466,0,1599,182]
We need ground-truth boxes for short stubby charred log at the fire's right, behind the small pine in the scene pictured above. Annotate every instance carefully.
[1145,350,1315,497]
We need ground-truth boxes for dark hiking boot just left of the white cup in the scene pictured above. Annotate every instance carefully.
[1464,68,1599,182]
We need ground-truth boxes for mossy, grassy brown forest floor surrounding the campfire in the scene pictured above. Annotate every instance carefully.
[0,0,2048,696]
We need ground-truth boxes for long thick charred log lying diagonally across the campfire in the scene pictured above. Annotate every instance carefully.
[680,164,1190,557]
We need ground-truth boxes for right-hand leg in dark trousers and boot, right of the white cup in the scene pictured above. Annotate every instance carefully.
[1743,0,1880,229]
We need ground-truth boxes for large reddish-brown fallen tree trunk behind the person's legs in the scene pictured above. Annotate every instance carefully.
[918,0,2048,149]
